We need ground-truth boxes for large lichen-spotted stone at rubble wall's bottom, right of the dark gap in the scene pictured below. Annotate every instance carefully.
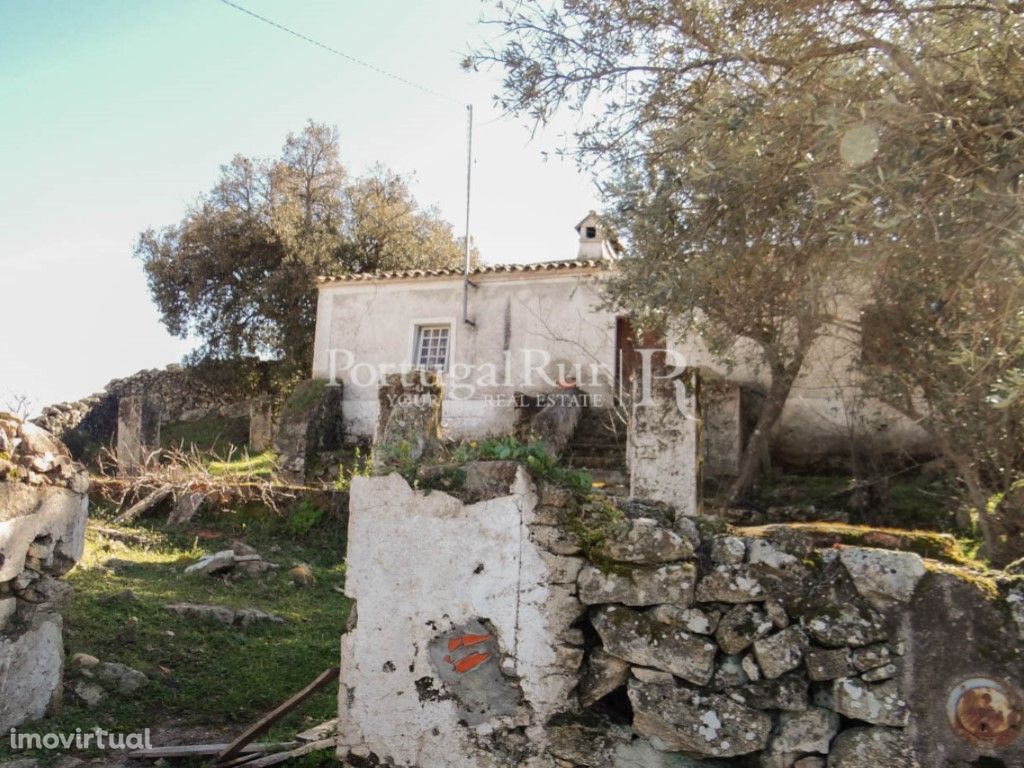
[629,680,771,758]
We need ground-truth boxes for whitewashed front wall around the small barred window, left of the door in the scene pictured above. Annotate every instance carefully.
[313,269,615,437]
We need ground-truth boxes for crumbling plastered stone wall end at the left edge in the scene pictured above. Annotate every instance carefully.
[0,414,89,731]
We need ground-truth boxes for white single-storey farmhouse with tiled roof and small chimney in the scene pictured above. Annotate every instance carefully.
[312,211,929,474]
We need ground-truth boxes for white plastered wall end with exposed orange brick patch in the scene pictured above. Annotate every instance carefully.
[338,462,583,768]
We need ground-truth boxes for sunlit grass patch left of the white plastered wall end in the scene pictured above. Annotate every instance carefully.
[0,495,350,765]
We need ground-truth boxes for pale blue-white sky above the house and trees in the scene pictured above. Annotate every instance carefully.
[0,0,598,413]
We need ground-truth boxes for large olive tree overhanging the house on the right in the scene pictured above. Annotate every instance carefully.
[468,0,1024,559]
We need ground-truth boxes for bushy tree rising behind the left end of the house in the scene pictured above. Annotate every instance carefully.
[135,122,463,372]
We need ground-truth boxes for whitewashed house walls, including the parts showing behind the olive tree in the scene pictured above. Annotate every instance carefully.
[313,269,930,460]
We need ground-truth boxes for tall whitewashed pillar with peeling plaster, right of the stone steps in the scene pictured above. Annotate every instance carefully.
[626,368,701,516]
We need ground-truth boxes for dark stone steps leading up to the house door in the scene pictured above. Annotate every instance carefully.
[565,408,629,496]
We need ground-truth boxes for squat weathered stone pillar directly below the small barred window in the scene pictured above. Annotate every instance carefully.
[374,371,444,470]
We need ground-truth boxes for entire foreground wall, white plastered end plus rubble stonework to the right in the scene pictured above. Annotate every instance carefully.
[339,465,1024,768]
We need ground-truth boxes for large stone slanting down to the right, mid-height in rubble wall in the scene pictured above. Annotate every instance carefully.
[592,605,717,685]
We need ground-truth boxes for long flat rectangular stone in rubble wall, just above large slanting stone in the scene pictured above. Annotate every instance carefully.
[579,563,696,607]
